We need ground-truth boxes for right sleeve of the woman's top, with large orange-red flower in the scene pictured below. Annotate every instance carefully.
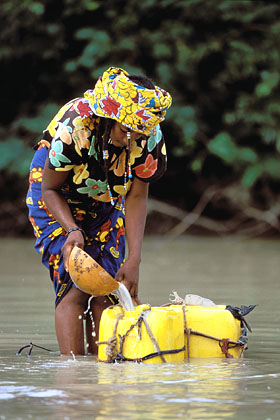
[132,125,167,182]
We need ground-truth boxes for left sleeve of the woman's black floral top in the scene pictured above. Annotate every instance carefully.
[44,103,90,171]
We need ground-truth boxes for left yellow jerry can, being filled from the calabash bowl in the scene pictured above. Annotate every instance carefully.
[98,305,184,363]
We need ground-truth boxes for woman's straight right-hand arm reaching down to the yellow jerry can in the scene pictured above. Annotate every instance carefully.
[116,178,149,303]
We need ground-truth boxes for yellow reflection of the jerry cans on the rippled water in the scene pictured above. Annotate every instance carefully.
[93,360,240,419]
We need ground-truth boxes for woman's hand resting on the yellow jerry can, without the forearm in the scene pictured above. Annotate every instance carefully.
[116,259,141,305]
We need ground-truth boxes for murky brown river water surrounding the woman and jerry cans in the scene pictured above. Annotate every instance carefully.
[0,236,280,420]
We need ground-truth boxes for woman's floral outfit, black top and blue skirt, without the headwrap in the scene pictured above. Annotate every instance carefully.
[26,98,166,305]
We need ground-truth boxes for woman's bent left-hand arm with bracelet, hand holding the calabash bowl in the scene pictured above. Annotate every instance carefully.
[42,159,84,271]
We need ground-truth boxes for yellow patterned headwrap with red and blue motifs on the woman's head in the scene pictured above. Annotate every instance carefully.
[84,67,172,135]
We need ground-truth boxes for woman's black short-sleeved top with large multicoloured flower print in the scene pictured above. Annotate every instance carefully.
[43,98,166,202]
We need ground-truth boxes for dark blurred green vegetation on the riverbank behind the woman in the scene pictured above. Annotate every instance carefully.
[0,0,280,233]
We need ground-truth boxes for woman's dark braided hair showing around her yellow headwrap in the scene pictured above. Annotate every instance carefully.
[95,74,155,199]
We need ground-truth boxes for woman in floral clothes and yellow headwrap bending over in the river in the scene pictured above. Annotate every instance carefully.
[27,67,171,355]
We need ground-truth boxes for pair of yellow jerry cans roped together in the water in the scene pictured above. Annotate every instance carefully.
[98,305,246,363]
